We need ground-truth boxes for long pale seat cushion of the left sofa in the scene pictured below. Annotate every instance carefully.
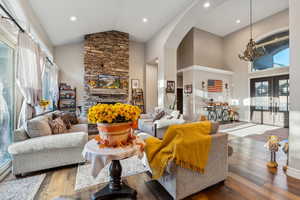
[8,132,88,155]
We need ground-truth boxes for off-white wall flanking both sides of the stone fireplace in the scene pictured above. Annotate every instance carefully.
[54,41,145,104]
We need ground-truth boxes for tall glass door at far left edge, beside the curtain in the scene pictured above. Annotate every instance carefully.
[0,41,14,172]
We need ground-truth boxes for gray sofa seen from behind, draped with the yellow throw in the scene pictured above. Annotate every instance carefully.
[139,133,228,200]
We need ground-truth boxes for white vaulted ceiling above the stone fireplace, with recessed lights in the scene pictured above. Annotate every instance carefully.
[29,0,193,45]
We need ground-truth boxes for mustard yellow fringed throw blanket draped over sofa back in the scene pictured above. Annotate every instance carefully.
[145,121,212,179]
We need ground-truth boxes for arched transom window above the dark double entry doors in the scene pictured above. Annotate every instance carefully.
[252,31,290,71]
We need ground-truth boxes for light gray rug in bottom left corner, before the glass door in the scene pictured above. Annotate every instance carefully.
[0,174,46,200]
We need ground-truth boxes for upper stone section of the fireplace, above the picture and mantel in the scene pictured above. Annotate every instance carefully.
[84,31,129,78]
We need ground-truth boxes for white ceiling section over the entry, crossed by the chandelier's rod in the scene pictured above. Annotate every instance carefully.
[196,0,289,36]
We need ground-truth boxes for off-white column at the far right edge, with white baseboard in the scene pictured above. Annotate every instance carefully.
[287,0,300,179]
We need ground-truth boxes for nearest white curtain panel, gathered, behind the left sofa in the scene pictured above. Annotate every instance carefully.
[16,32,42,127]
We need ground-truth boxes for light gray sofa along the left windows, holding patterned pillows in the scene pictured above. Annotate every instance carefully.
[8,113,88,175]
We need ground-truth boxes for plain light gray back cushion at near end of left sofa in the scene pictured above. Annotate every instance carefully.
[26,115,52,138]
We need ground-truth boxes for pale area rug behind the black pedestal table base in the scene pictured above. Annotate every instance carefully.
[75,156,149,191]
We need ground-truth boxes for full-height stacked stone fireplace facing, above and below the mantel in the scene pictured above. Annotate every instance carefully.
[84,31,129,114]
